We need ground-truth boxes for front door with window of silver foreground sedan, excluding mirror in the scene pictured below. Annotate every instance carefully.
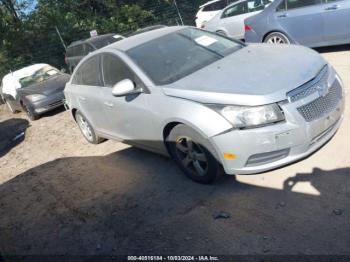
[102,53,155,147]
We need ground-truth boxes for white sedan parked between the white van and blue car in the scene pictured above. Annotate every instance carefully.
[202,0,272,39]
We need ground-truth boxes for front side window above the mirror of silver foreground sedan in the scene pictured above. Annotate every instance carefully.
[102,54,141,87]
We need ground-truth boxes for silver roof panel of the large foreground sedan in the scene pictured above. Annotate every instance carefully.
[106,26,185,52]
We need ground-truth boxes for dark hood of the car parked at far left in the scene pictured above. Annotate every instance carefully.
[17,74,70,96]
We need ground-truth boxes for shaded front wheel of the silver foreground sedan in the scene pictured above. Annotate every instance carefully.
[166,124,223,184]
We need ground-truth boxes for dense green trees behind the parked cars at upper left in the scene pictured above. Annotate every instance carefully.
[0,0,205,77]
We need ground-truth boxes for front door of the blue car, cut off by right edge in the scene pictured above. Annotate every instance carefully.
[323,0,350,44]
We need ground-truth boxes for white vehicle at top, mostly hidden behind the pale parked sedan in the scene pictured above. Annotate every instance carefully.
[196,0,238,28]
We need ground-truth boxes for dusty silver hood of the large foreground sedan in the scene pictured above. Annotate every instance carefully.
[163,44,327,106]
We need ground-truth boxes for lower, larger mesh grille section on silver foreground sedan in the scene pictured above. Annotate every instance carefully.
[298,80,342,122]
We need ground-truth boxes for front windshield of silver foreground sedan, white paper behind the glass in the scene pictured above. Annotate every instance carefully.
[127,28,243,85]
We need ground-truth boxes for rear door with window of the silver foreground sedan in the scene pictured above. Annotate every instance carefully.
[72,54,107,132]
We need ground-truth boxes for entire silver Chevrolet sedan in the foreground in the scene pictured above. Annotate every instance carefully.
[65,27,344,183]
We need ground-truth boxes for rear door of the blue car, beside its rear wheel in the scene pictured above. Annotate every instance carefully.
[275,0,324,46]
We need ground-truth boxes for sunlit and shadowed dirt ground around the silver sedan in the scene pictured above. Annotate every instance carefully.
[0,46,350,255]
